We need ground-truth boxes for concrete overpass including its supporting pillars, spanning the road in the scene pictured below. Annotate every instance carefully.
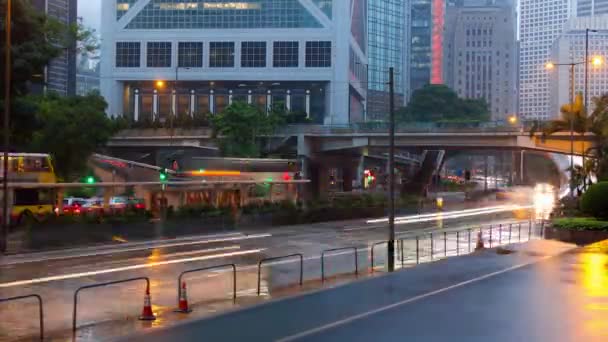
[108,125,594,193]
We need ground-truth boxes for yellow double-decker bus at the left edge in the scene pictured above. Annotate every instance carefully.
[0,153,57,225]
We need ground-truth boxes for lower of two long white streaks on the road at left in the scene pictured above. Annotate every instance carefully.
[0,248,265,288]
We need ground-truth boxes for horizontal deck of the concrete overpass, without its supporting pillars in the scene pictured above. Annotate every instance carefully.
[108,125,595,156]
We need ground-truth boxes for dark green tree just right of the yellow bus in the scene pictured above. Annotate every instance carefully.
[29,94,119,180]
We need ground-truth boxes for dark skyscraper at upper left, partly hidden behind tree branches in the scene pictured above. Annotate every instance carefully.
[32,0,78,95]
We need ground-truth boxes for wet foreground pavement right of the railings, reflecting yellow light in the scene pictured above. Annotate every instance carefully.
[125,241,608,341]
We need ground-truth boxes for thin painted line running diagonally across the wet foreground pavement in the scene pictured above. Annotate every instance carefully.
[276,256,553,342]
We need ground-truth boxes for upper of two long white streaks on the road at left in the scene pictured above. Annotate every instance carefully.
[0,234,272,266]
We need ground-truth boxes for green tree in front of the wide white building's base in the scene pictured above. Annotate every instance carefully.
[211,102,284,158]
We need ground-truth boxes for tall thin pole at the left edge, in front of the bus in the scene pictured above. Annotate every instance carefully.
[0,0,12,253]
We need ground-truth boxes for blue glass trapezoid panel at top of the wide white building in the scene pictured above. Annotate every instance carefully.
[127,0,322,30]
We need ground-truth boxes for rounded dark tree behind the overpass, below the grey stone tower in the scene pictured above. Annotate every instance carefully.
[397,84,490,122]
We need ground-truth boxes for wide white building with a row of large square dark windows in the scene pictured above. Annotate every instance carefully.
[101,0,368,125]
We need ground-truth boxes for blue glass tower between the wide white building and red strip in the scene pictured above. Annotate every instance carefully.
[367,0,409,120]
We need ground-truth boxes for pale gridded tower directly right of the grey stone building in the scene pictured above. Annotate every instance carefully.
[519,0,570,120]
